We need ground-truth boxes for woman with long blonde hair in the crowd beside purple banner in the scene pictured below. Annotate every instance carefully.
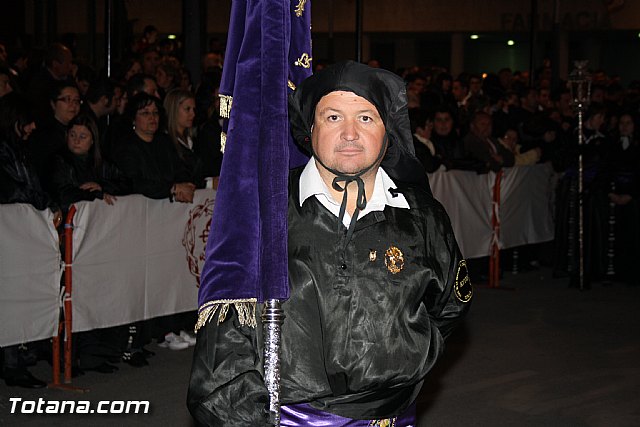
[164,89,205,188]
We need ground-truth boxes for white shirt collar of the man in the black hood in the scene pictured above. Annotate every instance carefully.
[300,157,410,228]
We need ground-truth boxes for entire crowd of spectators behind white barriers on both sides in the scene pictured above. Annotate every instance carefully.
[0,30,640,387]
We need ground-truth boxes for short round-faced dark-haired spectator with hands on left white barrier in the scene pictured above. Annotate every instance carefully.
[53,114,119,208]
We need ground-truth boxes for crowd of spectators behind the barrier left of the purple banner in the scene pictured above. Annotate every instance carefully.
[0,30,222,387]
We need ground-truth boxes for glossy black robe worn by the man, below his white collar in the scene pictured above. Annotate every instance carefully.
[188,170,471,426]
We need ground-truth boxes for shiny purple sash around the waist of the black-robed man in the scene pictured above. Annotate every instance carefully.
[280,403,416,427]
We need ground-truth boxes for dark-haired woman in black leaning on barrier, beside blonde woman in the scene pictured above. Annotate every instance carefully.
[115,93,196,203]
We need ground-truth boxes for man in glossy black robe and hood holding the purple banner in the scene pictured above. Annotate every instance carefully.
[188,61,472,427]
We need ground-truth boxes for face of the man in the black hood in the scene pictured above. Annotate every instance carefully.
[311,91,386,174]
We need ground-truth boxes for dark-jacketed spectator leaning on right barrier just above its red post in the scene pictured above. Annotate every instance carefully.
[464,111,515,172]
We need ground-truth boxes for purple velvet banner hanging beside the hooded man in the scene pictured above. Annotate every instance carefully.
[198,0,311,306]
